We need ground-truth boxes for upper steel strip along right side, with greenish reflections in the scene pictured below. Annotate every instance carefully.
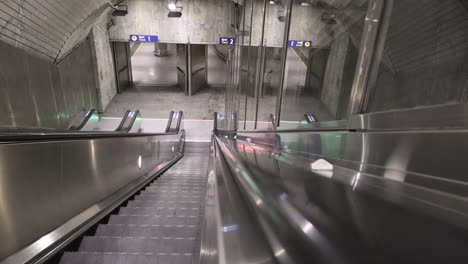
[238,131,468,197]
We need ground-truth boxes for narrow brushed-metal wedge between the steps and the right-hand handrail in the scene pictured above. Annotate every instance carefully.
[198,139,276,264]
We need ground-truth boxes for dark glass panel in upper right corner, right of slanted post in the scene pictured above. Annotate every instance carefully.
[365,0,468,112]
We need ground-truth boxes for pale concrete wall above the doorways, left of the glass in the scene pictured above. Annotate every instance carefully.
[110,0,233,44]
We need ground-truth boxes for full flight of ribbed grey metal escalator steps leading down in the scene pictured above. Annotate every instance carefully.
[60,143,209,264]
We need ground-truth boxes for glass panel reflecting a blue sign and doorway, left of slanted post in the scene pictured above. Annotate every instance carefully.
[281,0,369,126]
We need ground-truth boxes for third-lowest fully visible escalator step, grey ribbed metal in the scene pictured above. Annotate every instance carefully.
[108,215,199,225]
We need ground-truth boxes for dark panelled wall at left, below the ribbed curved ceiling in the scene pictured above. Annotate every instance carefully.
[0,40,97,128]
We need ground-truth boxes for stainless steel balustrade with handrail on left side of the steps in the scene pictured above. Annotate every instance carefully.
[0,111,185,263]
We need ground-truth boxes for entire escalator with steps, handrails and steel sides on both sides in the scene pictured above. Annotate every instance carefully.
[0,112,468,264]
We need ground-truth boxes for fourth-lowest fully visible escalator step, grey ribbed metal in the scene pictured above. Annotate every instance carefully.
[119,207,200,216]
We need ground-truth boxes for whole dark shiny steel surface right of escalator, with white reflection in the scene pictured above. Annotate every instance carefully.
[229,130,468,263]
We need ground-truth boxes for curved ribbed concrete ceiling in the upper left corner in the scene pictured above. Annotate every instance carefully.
[0,0,115,61]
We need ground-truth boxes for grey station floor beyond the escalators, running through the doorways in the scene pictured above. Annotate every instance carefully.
[103,43,226,120]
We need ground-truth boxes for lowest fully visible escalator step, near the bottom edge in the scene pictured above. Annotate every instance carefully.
[79,237,195,254]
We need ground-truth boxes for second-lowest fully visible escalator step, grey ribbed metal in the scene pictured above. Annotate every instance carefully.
[96,225,198,238]
